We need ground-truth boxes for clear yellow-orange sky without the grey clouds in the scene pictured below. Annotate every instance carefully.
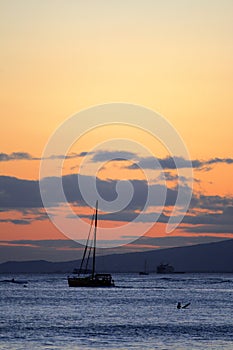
[0,0,233,256]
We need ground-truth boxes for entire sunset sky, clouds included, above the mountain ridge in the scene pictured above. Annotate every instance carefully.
[0,0,233,261]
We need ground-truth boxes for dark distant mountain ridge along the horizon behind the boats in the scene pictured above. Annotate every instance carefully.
[0,239,233,273]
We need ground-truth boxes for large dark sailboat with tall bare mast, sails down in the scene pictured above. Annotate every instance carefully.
[68,201,115,287]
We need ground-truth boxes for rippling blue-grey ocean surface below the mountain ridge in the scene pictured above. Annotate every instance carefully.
[0,274,233,350]
